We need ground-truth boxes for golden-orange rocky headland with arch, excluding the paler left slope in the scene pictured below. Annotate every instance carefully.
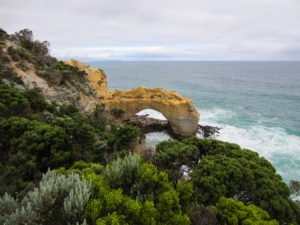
[64,60,199,138]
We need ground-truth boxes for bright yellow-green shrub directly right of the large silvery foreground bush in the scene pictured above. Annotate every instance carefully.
[84,173,158,225]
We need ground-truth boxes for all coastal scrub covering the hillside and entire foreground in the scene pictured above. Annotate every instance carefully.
[0,29,300,225]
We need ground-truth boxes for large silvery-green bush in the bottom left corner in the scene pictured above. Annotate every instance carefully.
[0,171,92,225]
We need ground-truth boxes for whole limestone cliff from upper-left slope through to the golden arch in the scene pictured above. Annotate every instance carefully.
[0,36,199,137]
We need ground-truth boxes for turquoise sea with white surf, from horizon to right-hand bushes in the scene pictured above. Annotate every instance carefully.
[89,62,300,182]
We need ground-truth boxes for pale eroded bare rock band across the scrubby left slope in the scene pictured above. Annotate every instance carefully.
[2,40,102,115]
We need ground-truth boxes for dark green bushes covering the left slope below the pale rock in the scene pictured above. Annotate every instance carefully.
[0,85,146,198]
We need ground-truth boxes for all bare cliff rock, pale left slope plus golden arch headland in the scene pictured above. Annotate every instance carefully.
[11,54,199,138]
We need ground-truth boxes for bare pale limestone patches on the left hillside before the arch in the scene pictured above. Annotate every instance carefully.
[0,40,102,114]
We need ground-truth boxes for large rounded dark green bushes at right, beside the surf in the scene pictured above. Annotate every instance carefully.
[154,137,300,223]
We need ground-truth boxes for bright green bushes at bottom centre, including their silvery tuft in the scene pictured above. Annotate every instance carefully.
[60,155,192,225]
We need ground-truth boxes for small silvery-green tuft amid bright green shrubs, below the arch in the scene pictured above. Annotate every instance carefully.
[105,154,141,192]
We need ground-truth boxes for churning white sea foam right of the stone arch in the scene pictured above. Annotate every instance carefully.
[199,109,300,182]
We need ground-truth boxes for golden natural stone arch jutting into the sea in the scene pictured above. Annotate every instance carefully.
[102,87,199,138]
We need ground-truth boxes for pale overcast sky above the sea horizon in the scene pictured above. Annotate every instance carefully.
[0,0,300,61]
